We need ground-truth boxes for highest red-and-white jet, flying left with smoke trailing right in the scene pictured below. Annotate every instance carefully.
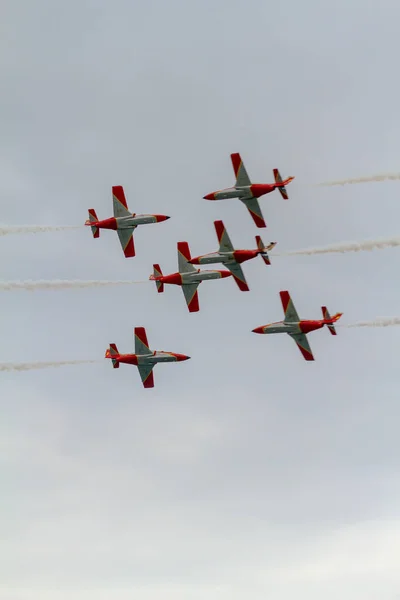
[203,152,294,227]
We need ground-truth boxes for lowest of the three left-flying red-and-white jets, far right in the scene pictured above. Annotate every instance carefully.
[253,291,343,360]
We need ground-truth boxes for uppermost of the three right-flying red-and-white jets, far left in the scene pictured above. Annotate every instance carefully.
[85,185,170,258]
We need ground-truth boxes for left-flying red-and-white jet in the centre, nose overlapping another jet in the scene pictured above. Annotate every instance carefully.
[189,221,276,292]
